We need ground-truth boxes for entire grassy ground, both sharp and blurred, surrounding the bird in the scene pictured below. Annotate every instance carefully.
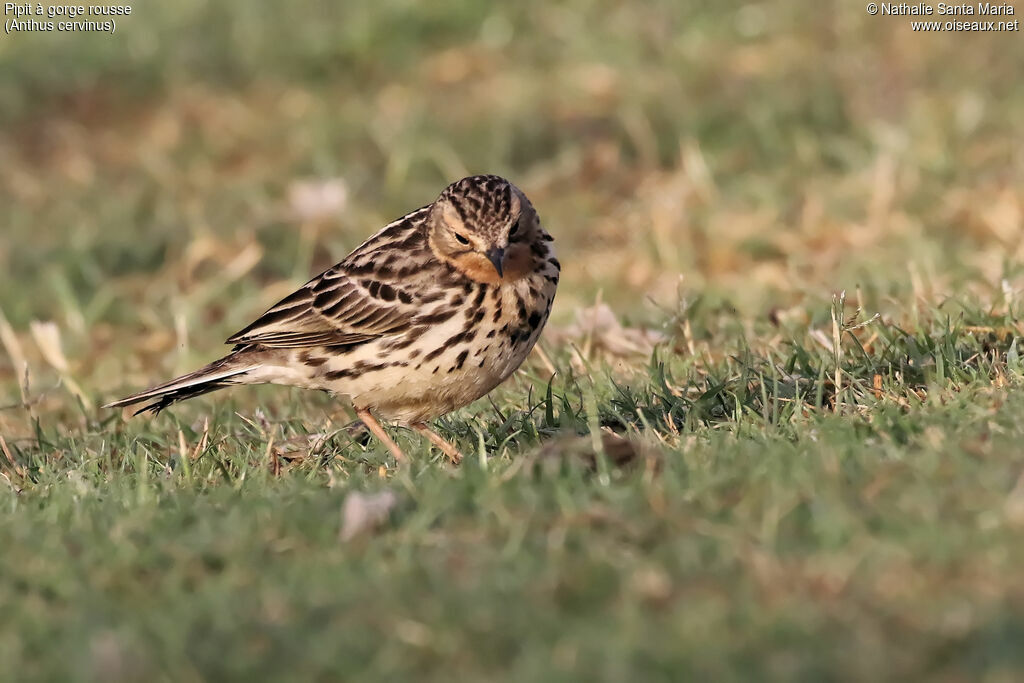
[0,0,1024,681]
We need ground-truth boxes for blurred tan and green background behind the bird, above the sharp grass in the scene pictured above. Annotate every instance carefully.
[0,0,1024,421]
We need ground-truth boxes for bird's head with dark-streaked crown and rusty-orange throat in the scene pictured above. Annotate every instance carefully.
[428,175,540,284]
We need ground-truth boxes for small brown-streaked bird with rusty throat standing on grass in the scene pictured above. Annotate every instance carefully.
[104,175,561,463]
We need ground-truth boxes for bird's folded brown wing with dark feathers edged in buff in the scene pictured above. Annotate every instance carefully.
[227,209,426,348]
